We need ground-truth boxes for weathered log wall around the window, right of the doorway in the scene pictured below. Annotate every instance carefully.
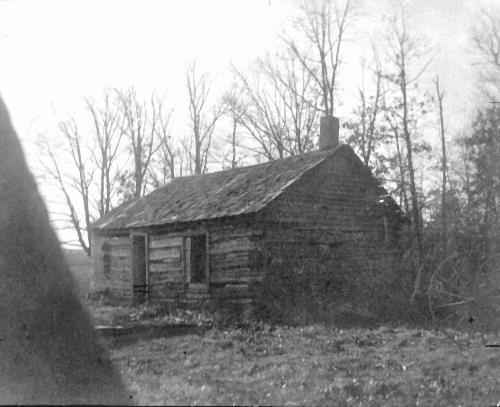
[143,223,262,301]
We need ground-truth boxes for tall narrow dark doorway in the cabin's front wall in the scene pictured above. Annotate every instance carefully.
[131,234,148,305]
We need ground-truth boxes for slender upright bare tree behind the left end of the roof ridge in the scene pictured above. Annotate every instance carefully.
[184,62,225,175]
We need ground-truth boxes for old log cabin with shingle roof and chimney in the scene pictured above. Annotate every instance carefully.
[91,116,407,304]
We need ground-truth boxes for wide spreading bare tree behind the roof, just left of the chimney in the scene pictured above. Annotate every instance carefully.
[233,54,319,160]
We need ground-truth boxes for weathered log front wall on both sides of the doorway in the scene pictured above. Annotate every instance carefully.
[92,223,262,302]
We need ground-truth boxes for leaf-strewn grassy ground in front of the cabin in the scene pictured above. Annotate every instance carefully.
[111,326,500,406]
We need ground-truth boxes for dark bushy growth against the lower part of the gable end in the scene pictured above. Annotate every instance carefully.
[254,247,409,325]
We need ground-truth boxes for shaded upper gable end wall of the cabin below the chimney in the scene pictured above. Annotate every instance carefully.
[259,151,406,258]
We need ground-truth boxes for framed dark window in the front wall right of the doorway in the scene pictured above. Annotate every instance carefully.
[185,233,209,285]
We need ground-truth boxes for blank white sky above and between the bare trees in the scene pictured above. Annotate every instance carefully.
[0,0,492,247]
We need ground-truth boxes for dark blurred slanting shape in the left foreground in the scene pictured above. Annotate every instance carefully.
[0,99,128,404]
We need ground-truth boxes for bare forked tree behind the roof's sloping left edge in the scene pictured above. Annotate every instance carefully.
[116,88,160,198]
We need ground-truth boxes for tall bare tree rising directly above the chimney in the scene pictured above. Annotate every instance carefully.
[284,0,356,115]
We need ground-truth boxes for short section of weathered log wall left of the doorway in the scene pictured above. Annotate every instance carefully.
[92,233,132,302]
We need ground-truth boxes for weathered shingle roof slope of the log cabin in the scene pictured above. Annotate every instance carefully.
[92,145,353,230]
